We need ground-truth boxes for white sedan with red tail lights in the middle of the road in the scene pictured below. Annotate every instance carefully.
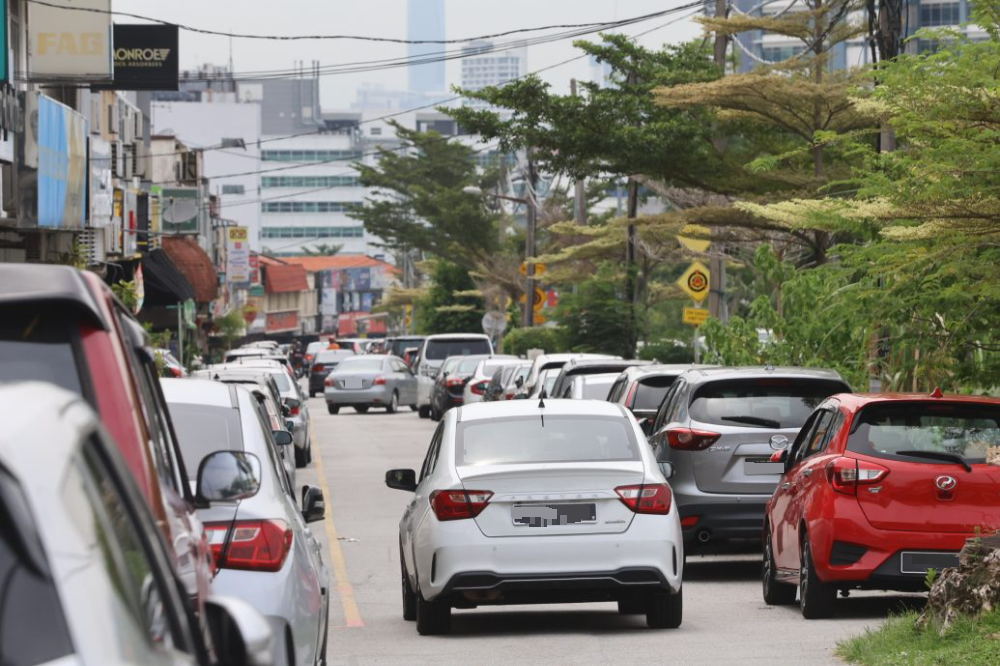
[386,400,684,634]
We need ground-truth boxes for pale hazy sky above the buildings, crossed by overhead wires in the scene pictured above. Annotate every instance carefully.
[113,0,701,109]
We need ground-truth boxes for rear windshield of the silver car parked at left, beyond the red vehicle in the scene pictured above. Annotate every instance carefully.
[169,402,243,481]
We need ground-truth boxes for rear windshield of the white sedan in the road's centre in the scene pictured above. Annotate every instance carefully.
[455,414,639,466]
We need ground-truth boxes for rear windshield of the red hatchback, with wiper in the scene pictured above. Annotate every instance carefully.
[847,402,1000,464]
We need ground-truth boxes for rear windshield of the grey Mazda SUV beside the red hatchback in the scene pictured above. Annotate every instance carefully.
[690,377,850,428]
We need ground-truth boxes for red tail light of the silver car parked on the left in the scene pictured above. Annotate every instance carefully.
[205,520,292,571]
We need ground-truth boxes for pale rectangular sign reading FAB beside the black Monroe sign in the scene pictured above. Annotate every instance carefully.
[28,0,112,83]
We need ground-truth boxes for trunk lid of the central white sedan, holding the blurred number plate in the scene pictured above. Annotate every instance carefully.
[458,461,644,537]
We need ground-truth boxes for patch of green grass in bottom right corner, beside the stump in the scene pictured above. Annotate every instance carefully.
[837,610,1000,666]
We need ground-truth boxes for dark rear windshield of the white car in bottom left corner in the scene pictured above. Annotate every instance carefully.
[0,467,73,666]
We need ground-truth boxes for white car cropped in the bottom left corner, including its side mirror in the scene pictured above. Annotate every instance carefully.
[0,378,271,666]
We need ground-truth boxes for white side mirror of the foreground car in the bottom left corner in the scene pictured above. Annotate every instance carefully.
[205,596,274,666]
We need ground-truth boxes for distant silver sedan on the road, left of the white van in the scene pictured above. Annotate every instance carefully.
[323,354,417,414]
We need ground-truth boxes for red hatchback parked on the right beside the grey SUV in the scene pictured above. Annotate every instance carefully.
[762,390,1000,618]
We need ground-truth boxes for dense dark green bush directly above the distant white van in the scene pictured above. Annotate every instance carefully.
[416,259,486,335]
